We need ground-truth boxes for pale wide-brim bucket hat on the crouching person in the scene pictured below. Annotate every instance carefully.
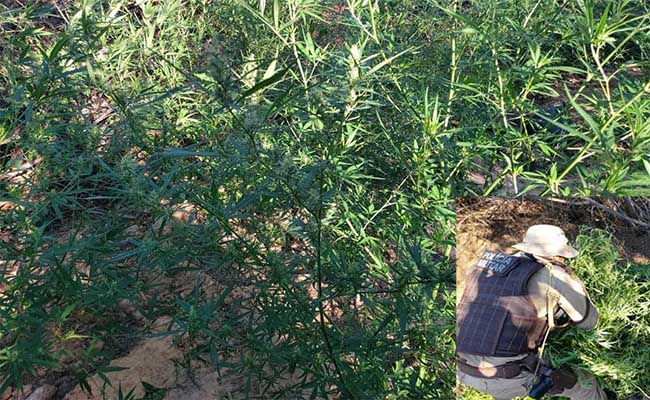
[512,225,578,258]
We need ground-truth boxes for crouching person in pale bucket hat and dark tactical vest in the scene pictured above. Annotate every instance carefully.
[456,225,611,400]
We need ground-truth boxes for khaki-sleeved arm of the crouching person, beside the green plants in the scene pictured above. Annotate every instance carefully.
[552,267,598,329]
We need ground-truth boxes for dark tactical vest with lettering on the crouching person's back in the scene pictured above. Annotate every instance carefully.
[456,251,547,357]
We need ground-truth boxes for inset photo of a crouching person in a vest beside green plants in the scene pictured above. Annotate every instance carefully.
[456,197,650,400]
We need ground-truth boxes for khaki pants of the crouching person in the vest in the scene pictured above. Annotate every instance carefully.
[456,371,607,400]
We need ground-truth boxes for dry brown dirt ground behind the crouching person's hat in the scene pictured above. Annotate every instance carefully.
[456,197,650,298]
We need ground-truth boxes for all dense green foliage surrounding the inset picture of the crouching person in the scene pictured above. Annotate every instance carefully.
[0,0,650,399]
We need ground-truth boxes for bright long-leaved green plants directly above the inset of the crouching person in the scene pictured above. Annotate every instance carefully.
[436,0,650,195]
